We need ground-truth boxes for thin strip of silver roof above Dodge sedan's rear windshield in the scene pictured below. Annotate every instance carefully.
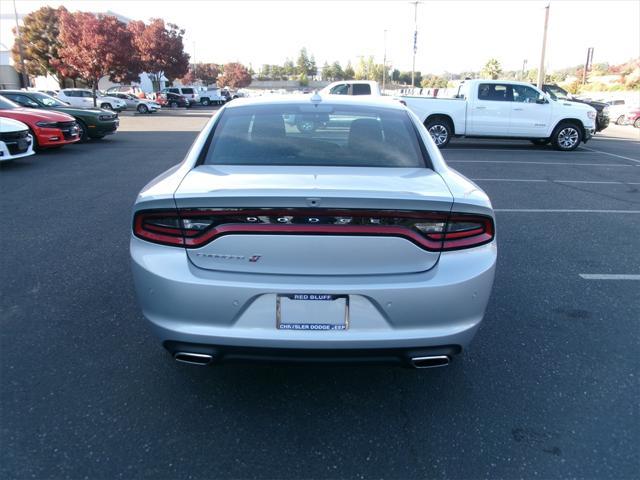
[226,93,405,110]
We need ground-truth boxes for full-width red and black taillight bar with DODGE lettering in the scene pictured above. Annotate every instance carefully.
[133,208,495,251]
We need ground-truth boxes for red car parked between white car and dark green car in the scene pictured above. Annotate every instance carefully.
[0,95,80,148]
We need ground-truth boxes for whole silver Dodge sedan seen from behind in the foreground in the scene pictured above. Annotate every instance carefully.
[130,94,497,368]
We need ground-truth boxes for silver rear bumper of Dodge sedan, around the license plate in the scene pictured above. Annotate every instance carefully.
[131,237,496,352]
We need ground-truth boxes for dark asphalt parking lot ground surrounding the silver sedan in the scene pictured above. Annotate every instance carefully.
[0,109,640,479]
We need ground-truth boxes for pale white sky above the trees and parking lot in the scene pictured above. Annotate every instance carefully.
[0,0,640,73]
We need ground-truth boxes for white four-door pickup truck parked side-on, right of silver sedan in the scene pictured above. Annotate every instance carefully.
[399,80,597,151]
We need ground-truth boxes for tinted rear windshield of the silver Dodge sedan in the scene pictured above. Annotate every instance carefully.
[204,103,429,168]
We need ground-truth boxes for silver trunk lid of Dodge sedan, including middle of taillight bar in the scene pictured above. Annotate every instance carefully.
[175,165,453,275]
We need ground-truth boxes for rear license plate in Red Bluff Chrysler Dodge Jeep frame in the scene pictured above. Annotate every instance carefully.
[276,293,349,331]
